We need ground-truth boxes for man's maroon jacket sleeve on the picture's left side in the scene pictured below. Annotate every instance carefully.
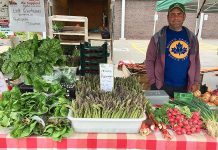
[145,37,157,85]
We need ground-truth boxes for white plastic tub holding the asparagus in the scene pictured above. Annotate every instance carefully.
[68,109,146,133]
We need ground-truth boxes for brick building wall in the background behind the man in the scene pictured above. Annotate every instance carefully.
[114,0,218,40]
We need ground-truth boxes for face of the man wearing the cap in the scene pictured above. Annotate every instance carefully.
[167,8,186,30]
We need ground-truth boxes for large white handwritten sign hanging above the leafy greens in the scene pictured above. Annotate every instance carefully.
[9,0,46,32]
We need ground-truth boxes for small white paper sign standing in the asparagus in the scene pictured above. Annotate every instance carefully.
[100,64,114,92]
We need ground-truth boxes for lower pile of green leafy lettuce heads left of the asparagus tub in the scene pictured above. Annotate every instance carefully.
[0,79,72,141]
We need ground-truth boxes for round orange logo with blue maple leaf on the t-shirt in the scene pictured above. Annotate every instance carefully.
[169,40,189,60]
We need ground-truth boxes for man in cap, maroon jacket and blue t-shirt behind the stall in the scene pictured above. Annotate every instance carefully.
[145,3,200,97]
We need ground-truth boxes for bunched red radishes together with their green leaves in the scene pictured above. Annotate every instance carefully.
[154,103,203,135]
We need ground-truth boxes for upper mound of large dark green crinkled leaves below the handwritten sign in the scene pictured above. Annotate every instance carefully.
[0,35,63,84]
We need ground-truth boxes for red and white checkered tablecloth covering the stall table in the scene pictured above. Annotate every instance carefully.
[0,131,218,150]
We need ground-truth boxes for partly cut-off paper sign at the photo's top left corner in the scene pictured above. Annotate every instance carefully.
[0,0,9,27]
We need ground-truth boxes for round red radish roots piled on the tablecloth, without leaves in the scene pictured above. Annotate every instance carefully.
[167,108,203,135]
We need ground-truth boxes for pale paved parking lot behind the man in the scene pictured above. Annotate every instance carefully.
[113,40,218,89]
